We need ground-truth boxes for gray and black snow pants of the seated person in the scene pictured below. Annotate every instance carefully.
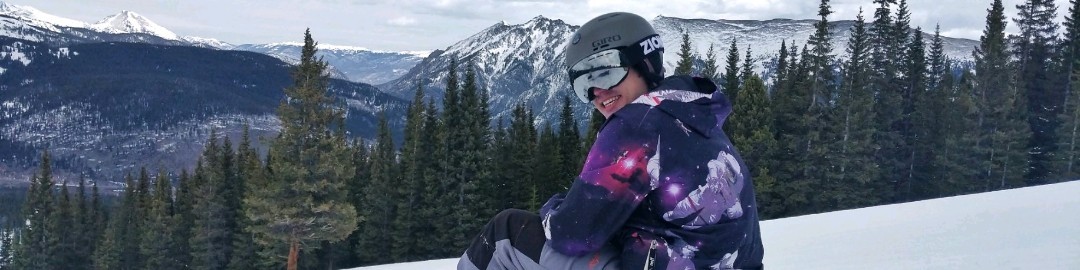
[458,210,619,270]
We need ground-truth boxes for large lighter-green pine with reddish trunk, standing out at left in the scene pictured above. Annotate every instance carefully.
[245,30,359,270]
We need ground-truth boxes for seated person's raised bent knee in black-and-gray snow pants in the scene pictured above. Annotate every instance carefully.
[458,210,548,270]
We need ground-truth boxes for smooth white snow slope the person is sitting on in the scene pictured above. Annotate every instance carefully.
[351,180,1080,270]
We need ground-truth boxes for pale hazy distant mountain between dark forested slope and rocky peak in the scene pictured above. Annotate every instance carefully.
[232,42,431,84]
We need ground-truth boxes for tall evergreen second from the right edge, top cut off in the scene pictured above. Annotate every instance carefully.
[1009,0,1064,185]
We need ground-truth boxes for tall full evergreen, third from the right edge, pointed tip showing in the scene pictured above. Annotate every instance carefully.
[973,0,1030,190]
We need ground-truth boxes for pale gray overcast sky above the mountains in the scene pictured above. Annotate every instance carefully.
[12,0,1068,51]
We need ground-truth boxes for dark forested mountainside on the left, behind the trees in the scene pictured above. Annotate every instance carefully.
[0,37,408,186]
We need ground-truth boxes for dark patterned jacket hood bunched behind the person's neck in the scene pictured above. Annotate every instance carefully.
[634,76,731,137]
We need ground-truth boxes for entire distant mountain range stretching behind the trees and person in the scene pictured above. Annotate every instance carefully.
[0,2,977,185]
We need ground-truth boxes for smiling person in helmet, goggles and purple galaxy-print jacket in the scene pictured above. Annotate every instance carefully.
[458,12,764,270]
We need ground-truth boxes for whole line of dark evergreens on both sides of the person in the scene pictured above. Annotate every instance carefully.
[0,0,1080,269]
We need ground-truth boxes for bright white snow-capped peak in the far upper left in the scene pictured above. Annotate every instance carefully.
[0,2,225,49]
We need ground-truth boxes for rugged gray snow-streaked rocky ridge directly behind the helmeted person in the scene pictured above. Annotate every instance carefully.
[379,16,977,123]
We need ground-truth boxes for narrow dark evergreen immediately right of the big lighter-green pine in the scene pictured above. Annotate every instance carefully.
[356,112,400,264]
